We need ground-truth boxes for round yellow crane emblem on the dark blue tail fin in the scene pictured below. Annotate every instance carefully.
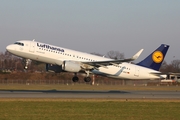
[152,51,163,63]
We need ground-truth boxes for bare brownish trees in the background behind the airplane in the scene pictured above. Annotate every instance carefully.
[0,51,180,73]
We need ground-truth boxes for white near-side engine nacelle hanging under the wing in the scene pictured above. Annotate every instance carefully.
[62,61,81,72]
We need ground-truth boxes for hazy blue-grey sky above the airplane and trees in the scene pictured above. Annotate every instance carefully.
[0,0,180,62]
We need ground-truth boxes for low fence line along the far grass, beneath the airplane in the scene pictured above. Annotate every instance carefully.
[0,79,178,86]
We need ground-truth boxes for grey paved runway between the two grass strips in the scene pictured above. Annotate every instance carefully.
[0,90,180,99]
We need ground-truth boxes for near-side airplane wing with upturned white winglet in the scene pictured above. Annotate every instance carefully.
[82,49,144,68]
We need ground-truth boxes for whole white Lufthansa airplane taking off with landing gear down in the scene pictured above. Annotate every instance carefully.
[6,39,169,82]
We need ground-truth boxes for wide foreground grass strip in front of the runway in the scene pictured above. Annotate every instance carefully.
[0,99,180,120]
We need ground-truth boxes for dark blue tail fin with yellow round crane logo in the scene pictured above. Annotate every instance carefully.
[137,44,169,71]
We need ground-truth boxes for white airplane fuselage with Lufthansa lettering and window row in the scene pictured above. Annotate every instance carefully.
[7,40,163,79]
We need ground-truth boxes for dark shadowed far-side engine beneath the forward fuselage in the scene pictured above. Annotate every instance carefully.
[46,64,63,73]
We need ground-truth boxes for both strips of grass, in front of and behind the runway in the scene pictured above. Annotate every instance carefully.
[0,84,180,120]
